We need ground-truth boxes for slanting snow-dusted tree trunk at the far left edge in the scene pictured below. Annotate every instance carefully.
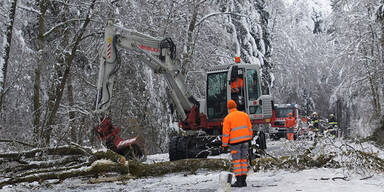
[0,0,17,113]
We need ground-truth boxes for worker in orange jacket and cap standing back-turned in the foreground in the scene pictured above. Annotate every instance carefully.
[222,100,252,187]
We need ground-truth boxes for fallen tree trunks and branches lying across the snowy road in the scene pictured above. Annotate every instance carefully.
[0,140,384,188]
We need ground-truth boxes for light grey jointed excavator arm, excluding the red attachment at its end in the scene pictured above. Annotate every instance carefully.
[96,21,197,120]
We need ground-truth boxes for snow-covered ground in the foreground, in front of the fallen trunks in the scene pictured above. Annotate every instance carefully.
[1,168,384,192]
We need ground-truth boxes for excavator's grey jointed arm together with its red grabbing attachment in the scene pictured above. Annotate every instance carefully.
[94,21,198,160]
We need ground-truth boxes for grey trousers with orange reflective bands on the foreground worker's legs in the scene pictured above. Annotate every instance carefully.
[231,142,249,176]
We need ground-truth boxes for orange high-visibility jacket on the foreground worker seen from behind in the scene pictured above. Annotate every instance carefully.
[222,108,252,147]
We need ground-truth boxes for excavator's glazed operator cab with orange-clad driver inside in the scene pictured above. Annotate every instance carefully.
[206,64,272,124]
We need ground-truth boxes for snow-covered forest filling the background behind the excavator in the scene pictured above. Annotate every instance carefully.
[0,0,384,154]
